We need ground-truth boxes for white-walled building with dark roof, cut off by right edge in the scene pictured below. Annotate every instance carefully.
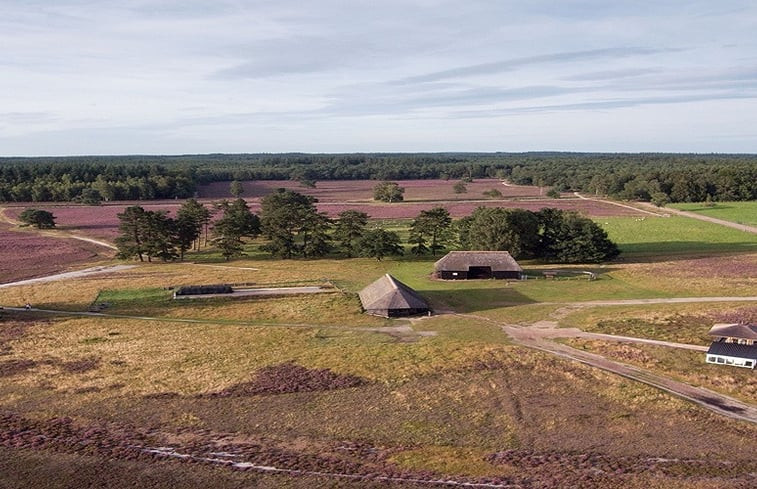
[706,324,757,369]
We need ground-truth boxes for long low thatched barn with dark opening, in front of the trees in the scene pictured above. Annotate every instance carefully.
[434,251,523,280]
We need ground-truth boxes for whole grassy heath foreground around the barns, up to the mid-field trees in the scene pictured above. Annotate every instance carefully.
[0,193,757,489]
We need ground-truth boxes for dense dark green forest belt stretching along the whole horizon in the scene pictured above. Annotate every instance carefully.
[0,153,757,204]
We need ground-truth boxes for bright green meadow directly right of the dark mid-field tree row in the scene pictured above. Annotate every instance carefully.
[595,216,757,255]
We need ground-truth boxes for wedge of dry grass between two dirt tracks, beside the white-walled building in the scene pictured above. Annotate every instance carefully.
[567,339,757,404]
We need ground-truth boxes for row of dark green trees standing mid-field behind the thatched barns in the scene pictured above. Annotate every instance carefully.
[116,189,619,263]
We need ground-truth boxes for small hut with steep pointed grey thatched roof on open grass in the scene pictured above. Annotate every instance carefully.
[359,273,429,318]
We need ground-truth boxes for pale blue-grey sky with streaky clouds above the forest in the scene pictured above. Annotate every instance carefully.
[0,0,757,156]
